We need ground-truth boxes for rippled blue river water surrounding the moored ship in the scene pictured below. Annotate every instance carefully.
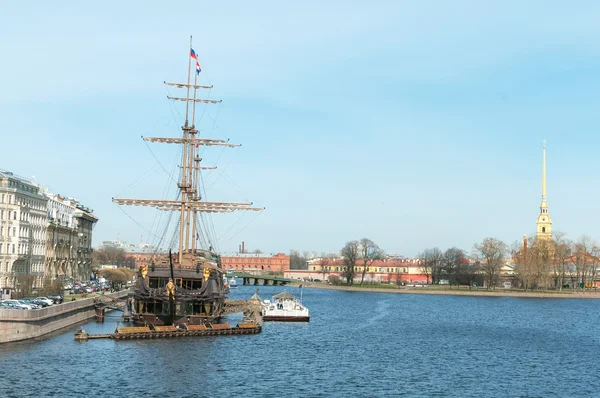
[0,286,600,397]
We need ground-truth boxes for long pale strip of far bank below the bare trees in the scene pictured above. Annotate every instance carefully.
[302,283,600,299]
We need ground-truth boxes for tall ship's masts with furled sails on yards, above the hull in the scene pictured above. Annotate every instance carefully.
[113,36,263,265]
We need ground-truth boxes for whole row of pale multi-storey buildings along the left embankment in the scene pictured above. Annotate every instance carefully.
[0,170,98,289]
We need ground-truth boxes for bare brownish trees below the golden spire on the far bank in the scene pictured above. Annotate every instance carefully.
[419,233,600,291]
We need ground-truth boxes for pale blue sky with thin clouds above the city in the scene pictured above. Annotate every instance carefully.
[0,0,600,257]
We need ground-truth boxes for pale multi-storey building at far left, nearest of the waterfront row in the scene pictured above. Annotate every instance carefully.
[0,170,48,288]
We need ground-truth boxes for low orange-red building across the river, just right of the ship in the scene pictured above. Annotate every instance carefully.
[221,253,290,272]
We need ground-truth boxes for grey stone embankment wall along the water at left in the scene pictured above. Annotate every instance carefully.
[0,291,127,344]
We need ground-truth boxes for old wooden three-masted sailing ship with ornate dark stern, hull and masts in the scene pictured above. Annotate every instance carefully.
[113,37,264,328]
